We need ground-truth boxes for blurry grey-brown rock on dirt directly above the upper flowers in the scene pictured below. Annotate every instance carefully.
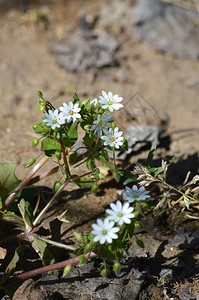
[51,14,119,72]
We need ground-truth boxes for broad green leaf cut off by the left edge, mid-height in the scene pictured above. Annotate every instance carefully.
[0,163,20,202]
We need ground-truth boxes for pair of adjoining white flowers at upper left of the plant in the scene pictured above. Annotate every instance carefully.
[43,101,81,129]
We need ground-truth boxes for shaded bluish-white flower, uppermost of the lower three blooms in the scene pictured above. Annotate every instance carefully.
[122,185,150,203]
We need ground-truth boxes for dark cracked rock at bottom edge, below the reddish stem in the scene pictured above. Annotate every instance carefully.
[39,260,143,300]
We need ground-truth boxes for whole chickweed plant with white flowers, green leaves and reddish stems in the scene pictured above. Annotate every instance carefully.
[0,91,199,295]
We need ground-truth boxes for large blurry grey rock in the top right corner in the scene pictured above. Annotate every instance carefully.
[133,0,199,60]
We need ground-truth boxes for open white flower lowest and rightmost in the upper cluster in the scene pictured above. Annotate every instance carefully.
[101,127,123,149]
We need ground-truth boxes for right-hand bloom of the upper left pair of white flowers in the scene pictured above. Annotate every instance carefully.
[59,101,81,123]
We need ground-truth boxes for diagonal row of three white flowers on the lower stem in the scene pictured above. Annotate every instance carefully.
[92,185,150,244]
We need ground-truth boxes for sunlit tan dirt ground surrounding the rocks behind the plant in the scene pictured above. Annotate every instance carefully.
[0,0,199,299]
